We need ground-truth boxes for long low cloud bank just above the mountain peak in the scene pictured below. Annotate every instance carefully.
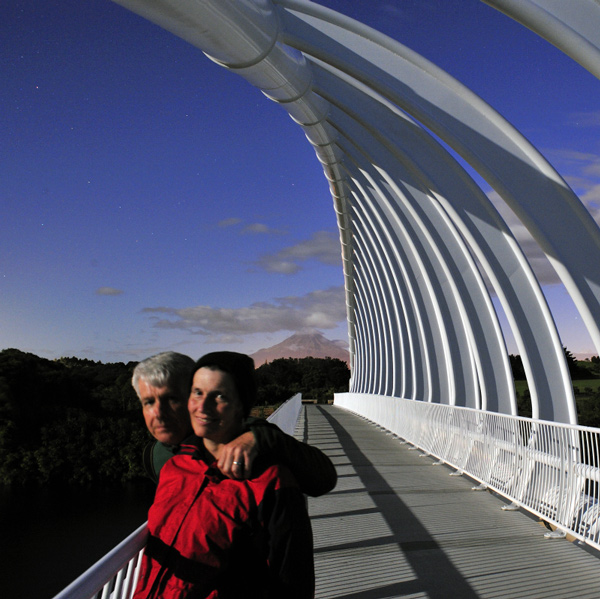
[142,286,346,340]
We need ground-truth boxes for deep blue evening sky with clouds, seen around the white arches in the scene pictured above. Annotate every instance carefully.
[0,0,600,362]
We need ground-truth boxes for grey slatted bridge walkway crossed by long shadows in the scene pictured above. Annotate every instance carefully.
[296,405,600,599]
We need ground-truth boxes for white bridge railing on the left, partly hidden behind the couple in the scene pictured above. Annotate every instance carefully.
[54,393,302,599]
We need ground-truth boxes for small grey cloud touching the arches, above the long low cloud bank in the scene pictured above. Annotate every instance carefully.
[257,231,342,274]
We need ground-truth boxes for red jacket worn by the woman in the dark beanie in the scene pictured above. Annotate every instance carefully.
[134,437,314,599]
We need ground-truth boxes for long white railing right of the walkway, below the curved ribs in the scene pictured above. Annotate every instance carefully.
[334,393,600,549]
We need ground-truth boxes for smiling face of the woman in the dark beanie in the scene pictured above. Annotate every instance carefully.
[188,368,244,443]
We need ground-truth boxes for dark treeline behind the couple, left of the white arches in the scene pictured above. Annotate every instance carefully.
[0,349,349,485]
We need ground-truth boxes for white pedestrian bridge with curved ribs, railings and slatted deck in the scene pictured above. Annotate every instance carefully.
[52,0,600,599]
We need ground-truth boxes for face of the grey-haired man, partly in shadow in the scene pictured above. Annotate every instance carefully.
[138,379,192,445]
